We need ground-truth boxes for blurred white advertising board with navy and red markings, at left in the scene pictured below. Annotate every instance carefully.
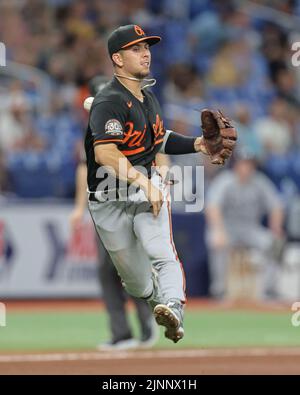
[0,203,101,298]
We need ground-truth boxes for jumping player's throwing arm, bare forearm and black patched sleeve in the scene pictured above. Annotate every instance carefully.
[90,102,163,217]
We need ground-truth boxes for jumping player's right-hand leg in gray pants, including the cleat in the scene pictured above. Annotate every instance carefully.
[134,187,186,342]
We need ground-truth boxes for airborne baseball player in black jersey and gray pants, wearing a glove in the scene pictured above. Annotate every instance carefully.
[85,25,236,343]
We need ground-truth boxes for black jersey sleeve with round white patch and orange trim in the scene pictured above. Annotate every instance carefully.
[90,101,126,146]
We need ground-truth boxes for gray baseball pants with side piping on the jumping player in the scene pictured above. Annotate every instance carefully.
[89,174,186,306]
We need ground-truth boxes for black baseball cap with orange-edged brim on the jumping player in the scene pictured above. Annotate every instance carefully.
[107,25,161,57]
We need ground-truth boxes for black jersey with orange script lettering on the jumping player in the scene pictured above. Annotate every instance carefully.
[85,78,166,191]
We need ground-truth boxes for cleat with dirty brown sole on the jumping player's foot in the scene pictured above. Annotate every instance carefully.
[153,304,184,343]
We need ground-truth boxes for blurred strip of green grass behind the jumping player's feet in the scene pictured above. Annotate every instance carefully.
[0,310,300,352]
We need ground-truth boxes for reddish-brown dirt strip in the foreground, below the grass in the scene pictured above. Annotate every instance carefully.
[0,348,300,375]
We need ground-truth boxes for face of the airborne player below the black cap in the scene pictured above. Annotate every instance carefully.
[122,42,151,78]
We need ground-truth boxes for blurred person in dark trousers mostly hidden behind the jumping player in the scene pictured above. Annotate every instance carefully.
[70,75,161,350]
